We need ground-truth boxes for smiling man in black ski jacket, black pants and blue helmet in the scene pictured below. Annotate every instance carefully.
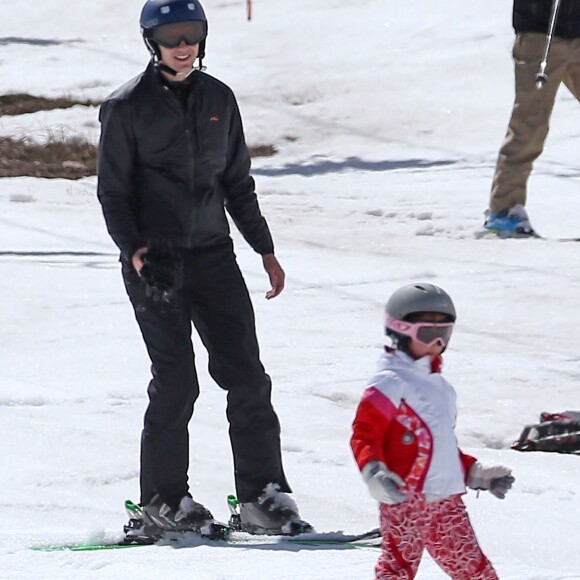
[98,0,309,537]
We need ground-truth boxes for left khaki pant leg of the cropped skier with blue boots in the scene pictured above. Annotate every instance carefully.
[490,32,572,212]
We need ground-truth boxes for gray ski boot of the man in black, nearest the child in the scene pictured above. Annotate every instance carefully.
[239,484,314,536]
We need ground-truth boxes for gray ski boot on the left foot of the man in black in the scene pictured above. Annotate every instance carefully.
[143,495,214,533]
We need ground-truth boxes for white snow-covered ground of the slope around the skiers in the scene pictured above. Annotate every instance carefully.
[0,0,580,580]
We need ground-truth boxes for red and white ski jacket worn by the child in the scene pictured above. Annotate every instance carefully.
[350,349,476,501]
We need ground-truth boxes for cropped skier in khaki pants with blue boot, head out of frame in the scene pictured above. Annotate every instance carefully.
[485,0,580,237]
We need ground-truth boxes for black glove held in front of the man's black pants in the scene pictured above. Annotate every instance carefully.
[139,242,183,303]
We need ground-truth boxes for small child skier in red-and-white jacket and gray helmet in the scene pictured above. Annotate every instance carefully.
[351,284,515,580]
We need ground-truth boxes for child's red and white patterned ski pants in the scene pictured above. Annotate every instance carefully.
[375,494,498,580]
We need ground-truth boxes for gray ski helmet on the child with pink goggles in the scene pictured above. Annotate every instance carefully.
[385,282,457,351]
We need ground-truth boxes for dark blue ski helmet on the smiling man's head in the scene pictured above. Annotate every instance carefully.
[139,0,207,67]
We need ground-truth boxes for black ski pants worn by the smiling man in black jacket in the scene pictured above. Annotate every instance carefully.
[123,243,291,507]
